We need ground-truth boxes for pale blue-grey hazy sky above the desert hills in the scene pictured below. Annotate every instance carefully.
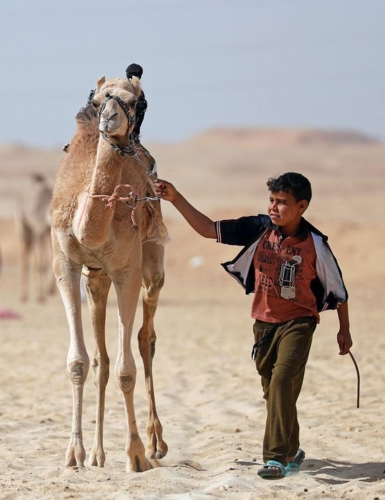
[0,0,385,148]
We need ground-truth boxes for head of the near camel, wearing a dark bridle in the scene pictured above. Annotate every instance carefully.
[92,77,137,142]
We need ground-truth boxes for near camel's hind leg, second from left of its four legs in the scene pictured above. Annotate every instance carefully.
[83,268,111,467]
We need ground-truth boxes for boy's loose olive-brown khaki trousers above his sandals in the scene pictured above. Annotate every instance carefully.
[254,317,317,465]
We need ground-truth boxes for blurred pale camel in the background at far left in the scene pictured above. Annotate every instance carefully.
[17,173,56,302]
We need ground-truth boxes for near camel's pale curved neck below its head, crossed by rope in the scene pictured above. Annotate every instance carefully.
[73,138,124,248]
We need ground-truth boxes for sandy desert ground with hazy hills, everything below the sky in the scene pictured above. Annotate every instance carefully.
[0,130,385,500]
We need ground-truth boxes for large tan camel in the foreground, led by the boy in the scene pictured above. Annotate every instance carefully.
[51,77,168,472]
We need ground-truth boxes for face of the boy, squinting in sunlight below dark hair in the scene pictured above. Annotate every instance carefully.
[267,191,309,227]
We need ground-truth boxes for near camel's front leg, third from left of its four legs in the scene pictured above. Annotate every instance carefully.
[113,269,152,472]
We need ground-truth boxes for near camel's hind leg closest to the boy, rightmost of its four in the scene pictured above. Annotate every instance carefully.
[138,242,168,459]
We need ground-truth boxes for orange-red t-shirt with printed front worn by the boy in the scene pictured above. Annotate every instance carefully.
[251,229,319,323]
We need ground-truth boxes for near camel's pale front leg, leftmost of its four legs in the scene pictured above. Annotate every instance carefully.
[53,241,89,467]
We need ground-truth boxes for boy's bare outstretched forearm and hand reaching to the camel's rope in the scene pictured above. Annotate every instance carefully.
[154,179,217,238]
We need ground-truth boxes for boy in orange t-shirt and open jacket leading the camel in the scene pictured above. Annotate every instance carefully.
[155,172,352,479]
